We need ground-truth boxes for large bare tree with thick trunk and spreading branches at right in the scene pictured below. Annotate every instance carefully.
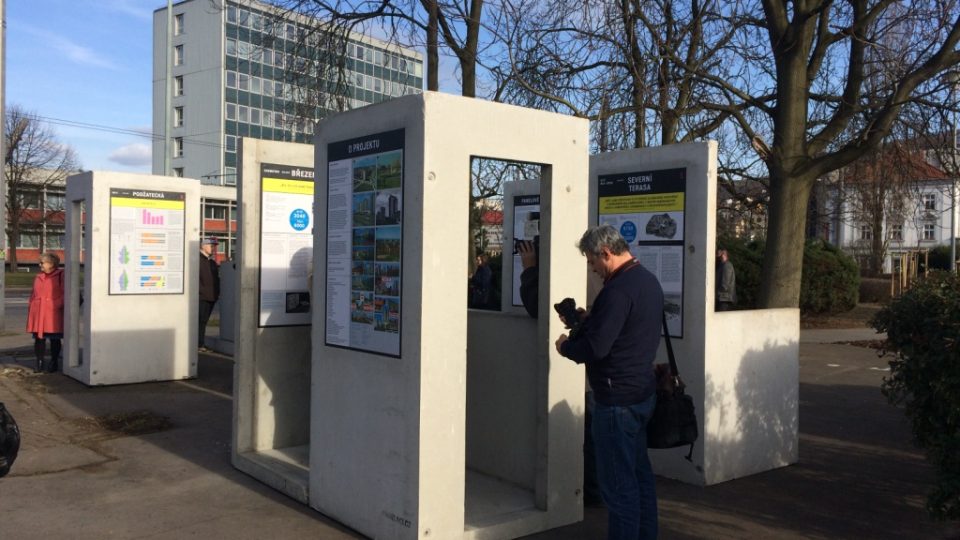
[692,0,960,307]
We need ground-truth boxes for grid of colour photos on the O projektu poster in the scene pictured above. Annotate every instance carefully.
[350,150,403,334]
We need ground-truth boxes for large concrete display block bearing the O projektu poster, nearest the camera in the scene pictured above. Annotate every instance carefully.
[309,93,589,539]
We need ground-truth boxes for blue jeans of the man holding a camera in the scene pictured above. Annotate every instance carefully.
[591,394,657,540]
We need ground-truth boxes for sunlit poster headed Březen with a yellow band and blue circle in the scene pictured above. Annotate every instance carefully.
[259,163,314,327]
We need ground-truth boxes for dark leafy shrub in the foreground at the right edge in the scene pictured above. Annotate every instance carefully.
[871,272,960,520]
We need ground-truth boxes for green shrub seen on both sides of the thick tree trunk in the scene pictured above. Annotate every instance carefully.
[717,237,860,313]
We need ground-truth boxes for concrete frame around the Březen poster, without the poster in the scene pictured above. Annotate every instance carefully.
[231,138,317,503]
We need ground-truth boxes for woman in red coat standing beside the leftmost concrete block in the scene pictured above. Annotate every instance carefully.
[27,253,63,373]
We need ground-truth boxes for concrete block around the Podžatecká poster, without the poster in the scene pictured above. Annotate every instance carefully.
[63,171,200,386]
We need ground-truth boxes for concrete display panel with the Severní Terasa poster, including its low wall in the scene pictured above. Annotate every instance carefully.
[590,142,800,485]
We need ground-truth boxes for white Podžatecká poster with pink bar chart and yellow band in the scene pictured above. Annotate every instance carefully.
[109,188,187,294]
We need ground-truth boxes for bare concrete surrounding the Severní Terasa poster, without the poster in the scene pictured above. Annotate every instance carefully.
[590,141,800,485]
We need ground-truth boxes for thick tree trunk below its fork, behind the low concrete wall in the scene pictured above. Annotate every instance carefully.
[757,171,816,308]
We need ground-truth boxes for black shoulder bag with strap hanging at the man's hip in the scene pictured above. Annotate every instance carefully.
[647,313,699,462]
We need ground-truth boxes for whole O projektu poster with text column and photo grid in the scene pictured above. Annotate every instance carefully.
[324,129,404,357]
